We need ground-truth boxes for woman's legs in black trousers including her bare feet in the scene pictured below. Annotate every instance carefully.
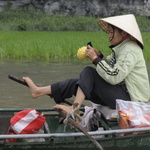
[23,67,130,112]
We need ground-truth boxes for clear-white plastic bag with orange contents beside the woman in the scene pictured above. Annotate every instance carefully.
[116,99,150,129]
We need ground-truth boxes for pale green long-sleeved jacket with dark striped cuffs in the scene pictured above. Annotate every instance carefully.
[96,39,150,102]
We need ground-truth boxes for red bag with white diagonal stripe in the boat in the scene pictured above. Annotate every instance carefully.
[10,109,46,134]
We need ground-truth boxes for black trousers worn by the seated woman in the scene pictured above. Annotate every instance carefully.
[50,67,131,109]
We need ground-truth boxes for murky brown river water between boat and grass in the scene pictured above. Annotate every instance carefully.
[0,60,150,108]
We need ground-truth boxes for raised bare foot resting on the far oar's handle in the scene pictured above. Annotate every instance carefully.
[23,77,40,98]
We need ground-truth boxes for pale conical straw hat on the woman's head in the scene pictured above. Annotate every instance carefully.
[98,14,144,48]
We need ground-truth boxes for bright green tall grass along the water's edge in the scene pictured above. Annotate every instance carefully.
[0,31,150,61]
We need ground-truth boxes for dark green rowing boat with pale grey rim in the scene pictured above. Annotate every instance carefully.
[0,108,150,150]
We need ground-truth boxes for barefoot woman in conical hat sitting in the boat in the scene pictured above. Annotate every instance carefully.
[23,14,150,113]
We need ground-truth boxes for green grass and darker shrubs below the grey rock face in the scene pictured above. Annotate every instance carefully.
[0,9,150,61]
